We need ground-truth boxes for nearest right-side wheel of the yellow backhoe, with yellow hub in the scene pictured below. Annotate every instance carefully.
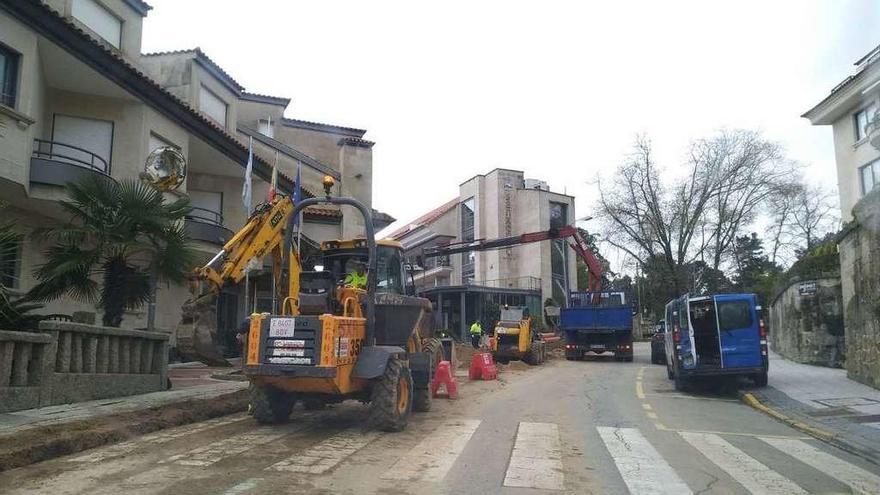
[369,357,413,431]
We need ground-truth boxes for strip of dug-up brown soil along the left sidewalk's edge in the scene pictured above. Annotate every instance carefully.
[0,390,248,471]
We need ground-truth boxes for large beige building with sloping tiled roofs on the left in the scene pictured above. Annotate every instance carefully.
[0,0,393,354]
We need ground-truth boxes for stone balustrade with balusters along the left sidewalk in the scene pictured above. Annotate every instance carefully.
[0,321,168,413]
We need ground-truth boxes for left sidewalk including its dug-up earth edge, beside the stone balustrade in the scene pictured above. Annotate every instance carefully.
[0,363,248,471]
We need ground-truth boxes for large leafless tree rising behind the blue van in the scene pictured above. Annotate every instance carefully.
[598,130,793,293]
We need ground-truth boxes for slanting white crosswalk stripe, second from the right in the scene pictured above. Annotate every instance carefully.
[679,431,807,495]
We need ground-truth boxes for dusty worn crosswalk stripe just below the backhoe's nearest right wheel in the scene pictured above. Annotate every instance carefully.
[266,429,379,474]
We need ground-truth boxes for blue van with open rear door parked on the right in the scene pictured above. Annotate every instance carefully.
[666,294,768,390]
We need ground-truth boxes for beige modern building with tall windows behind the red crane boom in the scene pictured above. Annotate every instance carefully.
[391,169,577,335]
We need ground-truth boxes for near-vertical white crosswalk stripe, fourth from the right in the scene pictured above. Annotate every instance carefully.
[504,422,565,490]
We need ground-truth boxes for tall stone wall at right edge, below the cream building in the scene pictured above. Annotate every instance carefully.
[838,188,880,388]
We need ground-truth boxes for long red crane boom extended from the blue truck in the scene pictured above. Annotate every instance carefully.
[424,225,602,292]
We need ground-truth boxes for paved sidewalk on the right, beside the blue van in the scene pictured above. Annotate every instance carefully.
[749,351,880,464]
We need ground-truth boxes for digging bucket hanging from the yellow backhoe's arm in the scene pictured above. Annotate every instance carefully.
[176,294,232,366]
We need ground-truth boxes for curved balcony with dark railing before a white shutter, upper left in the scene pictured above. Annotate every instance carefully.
[30,139,110,186]
